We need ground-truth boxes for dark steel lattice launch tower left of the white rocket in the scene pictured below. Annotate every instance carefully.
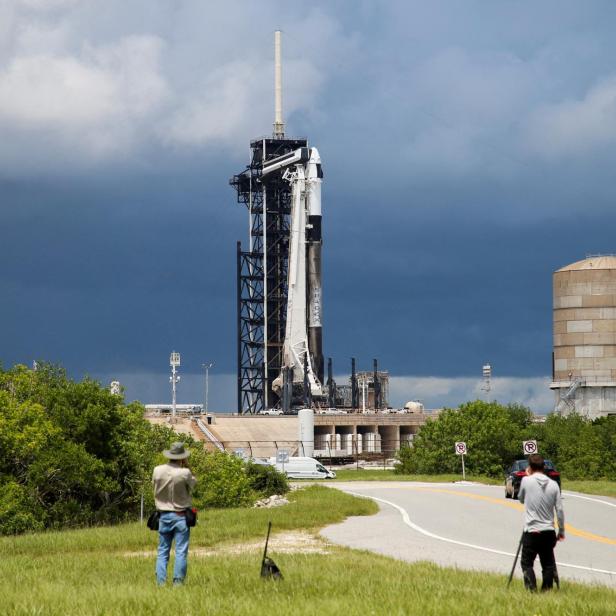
[230,135,308,414]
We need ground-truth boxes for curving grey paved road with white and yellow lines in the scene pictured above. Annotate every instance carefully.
[321,481,616,588]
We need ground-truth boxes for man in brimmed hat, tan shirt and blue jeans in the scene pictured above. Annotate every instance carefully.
[152,443,197,586]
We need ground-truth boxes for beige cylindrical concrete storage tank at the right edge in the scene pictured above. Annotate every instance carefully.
[550,255,616,419]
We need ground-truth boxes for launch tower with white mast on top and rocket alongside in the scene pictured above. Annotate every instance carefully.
[230,31,324,415]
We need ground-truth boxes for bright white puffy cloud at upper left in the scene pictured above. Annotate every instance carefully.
[0,36,166,129]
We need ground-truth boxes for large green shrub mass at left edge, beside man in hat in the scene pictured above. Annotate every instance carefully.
[0,363,177,534]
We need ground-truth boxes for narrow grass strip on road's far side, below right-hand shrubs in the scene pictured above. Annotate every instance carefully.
[331,469,616,498]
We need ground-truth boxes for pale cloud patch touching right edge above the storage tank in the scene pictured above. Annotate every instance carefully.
[526,76,616,159]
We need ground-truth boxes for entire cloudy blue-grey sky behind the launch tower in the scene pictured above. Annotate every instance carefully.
[0,0,616,411]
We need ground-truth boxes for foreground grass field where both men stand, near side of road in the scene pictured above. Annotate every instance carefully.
[0,486,616,616]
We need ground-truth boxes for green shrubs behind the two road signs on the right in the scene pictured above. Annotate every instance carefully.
[395,400,616,479]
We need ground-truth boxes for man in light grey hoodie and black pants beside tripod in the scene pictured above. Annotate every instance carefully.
[518,453,565,591]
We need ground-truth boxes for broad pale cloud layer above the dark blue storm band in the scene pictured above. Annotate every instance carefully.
[0,0,616,185]
